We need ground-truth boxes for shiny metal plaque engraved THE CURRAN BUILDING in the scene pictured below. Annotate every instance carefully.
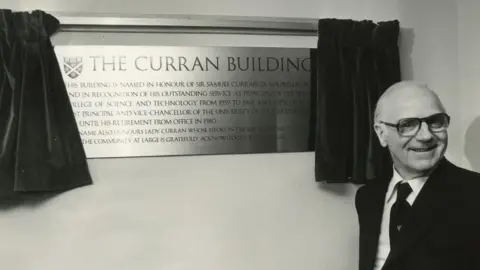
[55,46,311,158]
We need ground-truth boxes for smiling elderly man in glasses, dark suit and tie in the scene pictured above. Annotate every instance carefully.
[355,81,480,270]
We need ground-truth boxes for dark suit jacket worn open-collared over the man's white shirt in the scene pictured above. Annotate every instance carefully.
[355,158,480,270]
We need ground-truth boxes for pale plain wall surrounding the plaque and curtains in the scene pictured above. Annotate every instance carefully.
[0,0,463,270]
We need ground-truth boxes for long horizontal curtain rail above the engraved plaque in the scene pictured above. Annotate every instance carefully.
[49,12,318,36]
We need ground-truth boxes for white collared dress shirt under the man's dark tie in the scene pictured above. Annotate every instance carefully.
[374,168,428,270]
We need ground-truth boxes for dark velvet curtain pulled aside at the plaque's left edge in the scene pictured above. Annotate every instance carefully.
[0,10,92,199]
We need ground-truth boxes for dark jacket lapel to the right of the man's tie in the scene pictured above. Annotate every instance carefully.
[383,159,449,269]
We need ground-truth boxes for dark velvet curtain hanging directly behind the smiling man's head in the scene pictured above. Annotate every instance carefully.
[314,19,401,184]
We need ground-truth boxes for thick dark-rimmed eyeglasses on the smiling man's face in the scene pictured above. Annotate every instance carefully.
[380,113,450,137]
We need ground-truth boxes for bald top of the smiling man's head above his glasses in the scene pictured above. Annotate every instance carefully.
[374,81,445,123]
